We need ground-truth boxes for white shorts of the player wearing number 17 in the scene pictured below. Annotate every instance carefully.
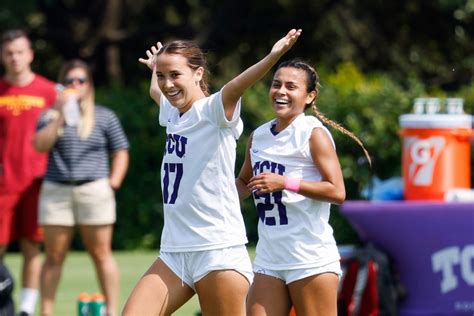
[160,245,253,291]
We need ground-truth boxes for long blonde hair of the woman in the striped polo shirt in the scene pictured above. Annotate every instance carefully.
[58,59,95,140]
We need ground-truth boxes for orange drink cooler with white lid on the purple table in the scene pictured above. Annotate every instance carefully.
[399,104,472,200]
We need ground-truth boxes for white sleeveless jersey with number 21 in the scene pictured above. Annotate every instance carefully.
[250,113,340,270]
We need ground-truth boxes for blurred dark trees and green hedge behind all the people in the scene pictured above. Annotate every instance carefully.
[0,0,474,249]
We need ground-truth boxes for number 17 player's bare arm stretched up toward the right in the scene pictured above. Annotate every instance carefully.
[222,29,302,120]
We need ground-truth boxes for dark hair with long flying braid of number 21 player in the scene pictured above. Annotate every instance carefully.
[277,59,372,165]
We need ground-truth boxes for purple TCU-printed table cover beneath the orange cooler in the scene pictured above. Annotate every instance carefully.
[341,201,474,316]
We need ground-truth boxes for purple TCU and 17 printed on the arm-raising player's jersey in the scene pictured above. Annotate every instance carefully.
[163,134,188,204]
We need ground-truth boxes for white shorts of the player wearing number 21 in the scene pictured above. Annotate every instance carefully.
[253,260,342,284]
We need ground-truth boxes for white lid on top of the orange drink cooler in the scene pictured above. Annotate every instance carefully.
[398,114,473,129]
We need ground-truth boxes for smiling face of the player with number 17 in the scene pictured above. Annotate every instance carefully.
[156,53,205,113]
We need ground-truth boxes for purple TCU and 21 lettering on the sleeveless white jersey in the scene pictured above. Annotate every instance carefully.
[252,160,288,226]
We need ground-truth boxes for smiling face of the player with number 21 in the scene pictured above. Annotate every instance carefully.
[269,67,317,125]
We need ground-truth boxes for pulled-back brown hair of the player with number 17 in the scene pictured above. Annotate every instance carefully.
[157,40,209,96]
